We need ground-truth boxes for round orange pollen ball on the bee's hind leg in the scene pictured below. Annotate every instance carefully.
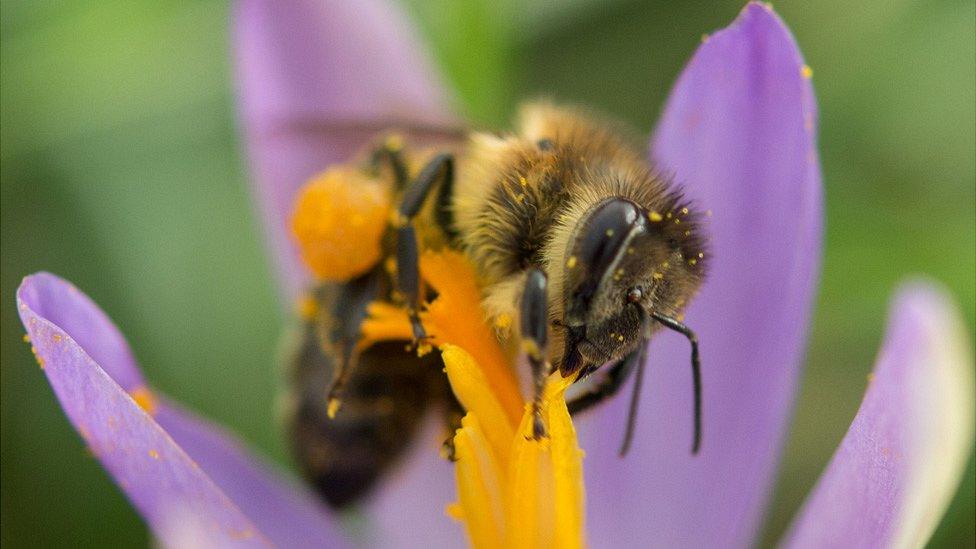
[291,165,390,282]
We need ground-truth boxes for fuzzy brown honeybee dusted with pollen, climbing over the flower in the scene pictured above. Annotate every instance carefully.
[289,102,708,507]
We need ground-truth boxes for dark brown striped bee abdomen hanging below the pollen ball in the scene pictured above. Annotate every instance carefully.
[288,316,440,508]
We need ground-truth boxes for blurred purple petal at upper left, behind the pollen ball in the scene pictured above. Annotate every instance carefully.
[235,0,455,298]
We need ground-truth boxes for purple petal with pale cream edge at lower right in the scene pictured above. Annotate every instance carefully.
[787,283,976,547]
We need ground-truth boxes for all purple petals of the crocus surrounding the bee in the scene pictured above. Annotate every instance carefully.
[17,0,974,547]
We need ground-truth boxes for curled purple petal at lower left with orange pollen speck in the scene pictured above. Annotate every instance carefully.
[17,273,341,546]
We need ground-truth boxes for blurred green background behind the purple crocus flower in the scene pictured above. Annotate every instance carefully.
[0,0,976,547]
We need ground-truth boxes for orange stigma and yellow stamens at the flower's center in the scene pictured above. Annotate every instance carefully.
[362,251,584,547]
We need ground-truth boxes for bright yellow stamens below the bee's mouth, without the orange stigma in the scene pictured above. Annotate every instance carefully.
[442,346,584,548]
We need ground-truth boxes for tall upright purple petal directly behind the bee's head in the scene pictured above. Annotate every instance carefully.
[581,3,822,547]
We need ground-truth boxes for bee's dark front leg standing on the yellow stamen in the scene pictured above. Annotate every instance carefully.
[521,268,550,440]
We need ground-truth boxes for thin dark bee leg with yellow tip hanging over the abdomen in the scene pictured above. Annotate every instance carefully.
[328,267,383,417]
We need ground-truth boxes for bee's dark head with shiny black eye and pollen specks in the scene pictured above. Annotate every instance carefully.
[560,197,705,376]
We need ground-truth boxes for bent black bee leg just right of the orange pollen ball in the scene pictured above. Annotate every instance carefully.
[394,154,454,346]
